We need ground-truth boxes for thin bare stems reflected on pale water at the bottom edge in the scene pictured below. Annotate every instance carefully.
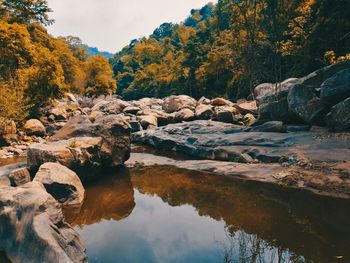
[219,229,307,263]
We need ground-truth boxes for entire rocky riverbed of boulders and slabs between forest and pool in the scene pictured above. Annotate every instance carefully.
[0,62,350,262]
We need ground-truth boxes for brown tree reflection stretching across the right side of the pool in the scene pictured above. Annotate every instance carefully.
[130,166,350,263]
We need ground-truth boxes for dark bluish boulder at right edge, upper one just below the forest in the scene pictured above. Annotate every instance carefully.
[321,68,350,106]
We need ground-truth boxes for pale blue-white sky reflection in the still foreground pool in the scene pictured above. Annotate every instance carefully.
[77,189,298,263]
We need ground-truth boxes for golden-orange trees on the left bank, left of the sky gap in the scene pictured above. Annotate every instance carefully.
[0,0,116,122]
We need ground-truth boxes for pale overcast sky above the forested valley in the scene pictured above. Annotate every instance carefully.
[48,0,215,53]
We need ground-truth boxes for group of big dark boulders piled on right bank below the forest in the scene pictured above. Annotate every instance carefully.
[255,61,350,131]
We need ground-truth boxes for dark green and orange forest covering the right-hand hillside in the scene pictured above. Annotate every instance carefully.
[111,0,350,99]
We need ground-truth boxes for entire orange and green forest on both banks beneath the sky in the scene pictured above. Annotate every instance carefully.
[0,0,350,122]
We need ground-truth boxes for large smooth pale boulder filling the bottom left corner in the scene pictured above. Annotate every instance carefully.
[0,182,87,263]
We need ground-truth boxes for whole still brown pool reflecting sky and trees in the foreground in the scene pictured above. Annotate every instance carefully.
[65,167,350,263]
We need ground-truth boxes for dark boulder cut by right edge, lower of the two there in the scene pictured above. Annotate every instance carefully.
[326,98,350,132]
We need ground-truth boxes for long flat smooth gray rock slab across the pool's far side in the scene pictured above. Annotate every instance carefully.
[132,121,350,163]
